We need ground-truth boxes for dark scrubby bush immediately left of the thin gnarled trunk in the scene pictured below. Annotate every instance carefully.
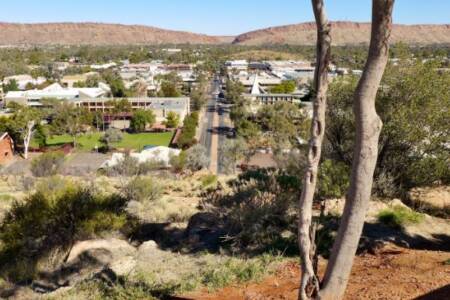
[202,170,300,252]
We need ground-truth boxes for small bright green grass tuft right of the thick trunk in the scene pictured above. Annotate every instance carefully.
[378,205,424,228]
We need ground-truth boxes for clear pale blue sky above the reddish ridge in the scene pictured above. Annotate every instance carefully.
[0,0,450,35]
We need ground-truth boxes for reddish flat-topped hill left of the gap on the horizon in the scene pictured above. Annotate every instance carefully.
[0,23,225,45]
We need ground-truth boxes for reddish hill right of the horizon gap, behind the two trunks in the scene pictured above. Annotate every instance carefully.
[233,22,450,45]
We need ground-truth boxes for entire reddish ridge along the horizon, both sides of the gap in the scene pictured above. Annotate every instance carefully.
[0,22,450,46]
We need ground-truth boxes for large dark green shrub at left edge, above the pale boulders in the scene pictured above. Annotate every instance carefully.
[0,185,126,281]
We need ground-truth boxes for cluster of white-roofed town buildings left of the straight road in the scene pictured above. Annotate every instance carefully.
[0,58,197,128]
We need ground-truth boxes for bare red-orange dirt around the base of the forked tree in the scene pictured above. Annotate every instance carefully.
[183,246,450,300]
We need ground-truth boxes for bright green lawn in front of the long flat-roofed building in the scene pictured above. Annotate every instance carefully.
[32,132,173,151]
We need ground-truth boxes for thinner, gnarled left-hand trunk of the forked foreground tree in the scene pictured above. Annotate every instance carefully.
[298,0,331,299]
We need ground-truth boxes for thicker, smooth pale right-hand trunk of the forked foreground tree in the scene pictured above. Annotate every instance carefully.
[319,0,394,299]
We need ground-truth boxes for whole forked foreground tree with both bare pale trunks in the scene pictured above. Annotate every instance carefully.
[299,0,394,299]
